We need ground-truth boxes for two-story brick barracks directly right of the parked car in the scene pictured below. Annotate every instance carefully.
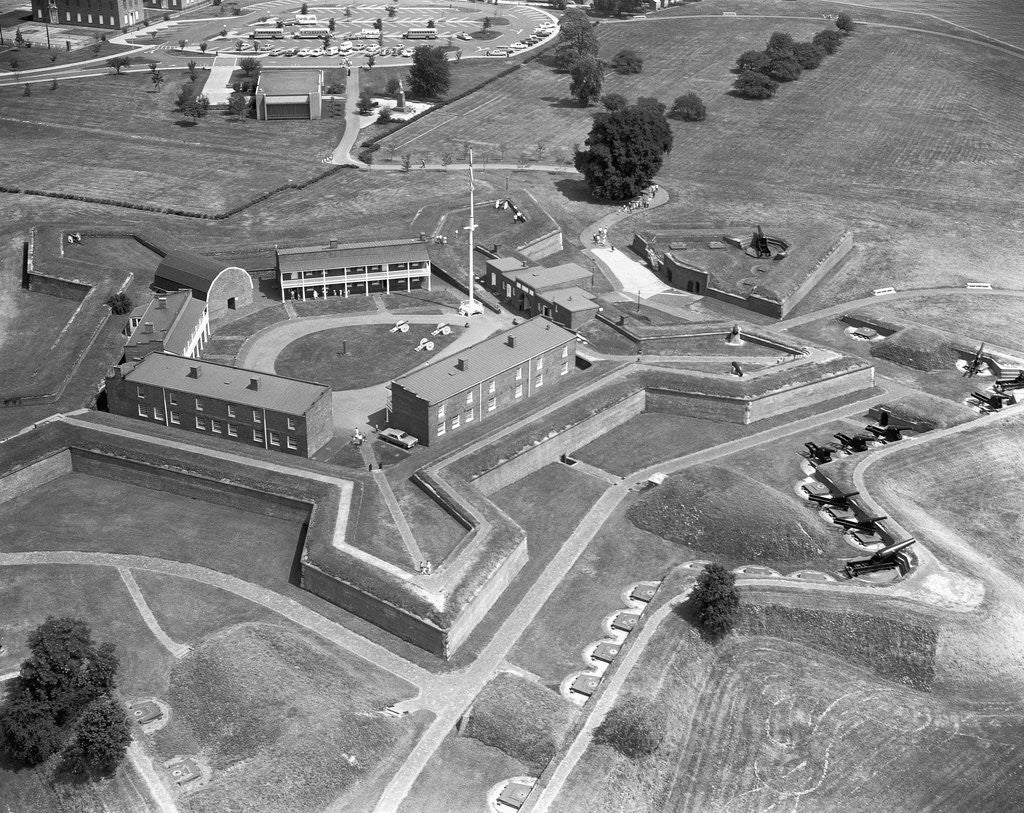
[388,316,577,445]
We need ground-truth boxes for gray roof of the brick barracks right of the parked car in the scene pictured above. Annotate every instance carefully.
[392,316,575,403]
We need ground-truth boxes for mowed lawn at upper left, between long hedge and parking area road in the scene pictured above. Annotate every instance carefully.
[0,71,343,212]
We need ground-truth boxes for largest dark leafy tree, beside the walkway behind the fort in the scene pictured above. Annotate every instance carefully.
[574,100,672,201]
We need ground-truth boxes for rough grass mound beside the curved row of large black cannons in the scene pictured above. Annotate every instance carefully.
[627,466,834,564]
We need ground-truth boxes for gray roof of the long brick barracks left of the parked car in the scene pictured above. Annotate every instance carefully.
[121,352,331,415]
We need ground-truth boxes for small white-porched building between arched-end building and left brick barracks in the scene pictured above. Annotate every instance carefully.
[124,290,210,361]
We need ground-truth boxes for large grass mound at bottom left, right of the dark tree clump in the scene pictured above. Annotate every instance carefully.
[156,624,417,813]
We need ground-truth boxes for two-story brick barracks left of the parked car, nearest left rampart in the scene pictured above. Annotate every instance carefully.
[106,352,334,458]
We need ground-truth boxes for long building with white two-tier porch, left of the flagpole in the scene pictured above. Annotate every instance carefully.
[278,240,432,301]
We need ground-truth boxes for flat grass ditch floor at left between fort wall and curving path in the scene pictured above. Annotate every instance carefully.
[0,473,300,588]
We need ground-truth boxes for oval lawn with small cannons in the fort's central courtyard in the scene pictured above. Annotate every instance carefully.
[274,325,463,392]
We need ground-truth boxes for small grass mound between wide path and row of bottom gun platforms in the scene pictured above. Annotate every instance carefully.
[462,672,577,773]
